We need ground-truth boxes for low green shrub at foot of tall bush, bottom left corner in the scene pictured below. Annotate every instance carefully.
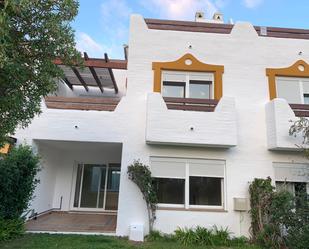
[0,218,24,241]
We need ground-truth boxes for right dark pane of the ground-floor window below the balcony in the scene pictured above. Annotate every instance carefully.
[189,176,222,206]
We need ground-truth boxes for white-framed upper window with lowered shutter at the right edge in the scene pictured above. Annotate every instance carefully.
[276,77,309,104]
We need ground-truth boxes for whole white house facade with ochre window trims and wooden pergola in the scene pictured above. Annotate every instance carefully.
[15,15,309,239]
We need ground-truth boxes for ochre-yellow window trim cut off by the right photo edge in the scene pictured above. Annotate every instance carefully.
[266,60,309,100]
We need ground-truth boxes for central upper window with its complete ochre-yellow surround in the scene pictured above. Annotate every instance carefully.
[152,54,224,100]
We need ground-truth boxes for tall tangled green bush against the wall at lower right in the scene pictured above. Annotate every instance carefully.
[249,178,309,249]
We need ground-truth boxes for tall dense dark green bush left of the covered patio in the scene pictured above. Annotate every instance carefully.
[0,145,39,240]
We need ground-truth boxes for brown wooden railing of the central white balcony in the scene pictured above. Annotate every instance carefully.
[163,97,219,112]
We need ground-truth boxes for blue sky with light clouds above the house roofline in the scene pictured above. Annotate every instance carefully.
[72,0,309,59]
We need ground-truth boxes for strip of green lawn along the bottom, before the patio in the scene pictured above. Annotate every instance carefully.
[0,234,259,249]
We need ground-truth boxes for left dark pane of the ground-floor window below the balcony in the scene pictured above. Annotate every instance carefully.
[154,178,185,204]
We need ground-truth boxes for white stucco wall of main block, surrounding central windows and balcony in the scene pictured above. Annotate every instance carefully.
[117,15,309,235]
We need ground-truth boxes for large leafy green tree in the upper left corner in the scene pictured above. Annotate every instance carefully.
[0,0,81,144]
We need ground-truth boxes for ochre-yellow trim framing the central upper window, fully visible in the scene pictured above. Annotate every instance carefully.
[152,54,224,100]
